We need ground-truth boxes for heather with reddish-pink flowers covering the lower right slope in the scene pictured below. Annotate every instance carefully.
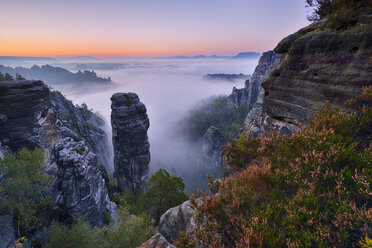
[177,87,372,248]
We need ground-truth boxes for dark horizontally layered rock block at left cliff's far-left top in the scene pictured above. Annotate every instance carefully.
[0,81,49,151]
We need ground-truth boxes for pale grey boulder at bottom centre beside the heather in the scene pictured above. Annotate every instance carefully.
[157,198,202,243]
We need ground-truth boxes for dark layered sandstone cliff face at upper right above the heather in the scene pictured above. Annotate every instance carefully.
[262,16,372,125]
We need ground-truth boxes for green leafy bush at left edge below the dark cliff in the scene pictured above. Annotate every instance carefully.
[0,148,51,236]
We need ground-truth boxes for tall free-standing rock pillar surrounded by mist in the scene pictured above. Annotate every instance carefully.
[111,93,150,191]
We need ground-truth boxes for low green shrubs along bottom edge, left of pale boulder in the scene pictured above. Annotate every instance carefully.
[46,208,154,248]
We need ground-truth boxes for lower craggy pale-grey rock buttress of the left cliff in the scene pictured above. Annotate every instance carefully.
[53,137,116,226]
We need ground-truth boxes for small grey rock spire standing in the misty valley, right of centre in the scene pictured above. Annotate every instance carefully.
[202,126,225,168]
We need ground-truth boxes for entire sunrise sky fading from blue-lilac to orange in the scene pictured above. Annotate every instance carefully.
[0,0,309,57]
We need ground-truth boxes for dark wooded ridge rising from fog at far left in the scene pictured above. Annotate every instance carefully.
[0,65,111,85]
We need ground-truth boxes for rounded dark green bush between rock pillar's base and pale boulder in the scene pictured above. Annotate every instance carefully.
[144,169,187,222]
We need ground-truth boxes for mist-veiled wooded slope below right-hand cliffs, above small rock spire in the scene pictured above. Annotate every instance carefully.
[181,96,248,140]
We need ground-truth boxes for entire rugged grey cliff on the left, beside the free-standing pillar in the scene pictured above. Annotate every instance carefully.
[0,81,116,226]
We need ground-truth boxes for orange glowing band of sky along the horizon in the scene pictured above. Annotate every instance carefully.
[0,37,268,57]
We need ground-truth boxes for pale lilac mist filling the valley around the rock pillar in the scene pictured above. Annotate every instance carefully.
[13,58,258,191]
